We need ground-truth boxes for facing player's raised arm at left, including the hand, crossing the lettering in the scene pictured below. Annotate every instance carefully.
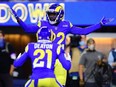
[11,9,39,33]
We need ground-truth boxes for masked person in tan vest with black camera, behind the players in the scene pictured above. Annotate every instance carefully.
[66,35,86,87]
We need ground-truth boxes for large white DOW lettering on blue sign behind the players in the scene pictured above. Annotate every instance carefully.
[0,3,64,23]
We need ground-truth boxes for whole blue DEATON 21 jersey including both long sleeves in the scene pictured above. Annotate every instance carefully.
[14,40,71,79]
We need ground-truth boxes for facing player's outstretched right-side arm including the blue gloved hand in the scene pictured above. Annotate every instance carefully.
[71,17,113,35]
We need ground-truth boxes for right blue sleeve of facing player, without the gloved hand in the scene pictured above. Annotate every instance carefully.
[70,23,101,35]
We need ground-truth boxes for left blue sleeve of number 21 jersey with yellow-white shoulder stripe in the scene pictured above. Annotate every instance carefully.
[14,44,29,67]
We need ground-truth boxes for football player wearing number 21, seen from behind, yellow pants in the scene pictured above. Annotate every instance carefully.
[14,27,71,87]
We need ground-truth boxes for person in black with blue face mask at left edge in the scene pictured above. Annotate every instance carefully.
[0,30,16,87]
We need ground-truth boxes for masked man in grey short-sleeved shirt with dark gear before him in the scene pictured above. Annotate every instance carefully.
[79,38,111,87]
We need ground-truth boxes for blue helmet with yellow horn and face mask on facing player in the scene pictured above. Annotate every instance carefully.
[46,4,64,24]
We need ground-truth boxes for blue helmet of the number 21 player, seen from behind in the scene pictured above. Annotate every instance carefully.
[36,26,51,40]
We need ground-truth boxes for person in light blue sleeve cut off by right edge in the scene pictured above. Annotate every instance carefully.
[108,39,116,87]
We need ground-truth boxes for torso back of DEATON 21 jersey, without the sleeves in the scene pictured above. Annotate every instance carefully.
[28,40,58,78]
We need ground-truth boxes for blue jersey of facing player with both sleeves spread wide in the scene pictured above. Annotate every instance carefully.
[19,20,101,44]
